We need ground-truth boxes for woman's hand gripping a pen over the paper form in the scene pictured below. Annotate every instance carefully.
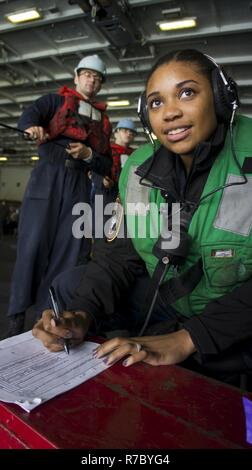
[32,310,92,352]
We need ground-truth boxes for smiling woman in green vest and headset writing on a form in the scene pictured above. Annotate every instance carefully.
[33,50,252,386]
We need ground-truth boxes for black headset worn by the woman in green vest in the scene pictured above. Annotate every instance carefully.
[137,54,240,135]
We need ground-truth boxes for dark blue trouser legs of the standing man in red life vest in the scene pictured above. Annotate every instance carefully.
[8,160,91,315]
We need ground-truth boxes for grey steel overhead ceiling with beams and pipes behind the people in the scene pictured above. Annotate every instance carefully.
[0,0,252,163]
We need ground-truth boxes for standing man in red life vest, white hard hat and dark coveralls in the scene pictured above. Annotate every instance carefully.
[7,55,112,336]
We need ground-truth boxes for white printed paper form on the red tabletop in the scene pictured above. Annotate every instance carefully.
[0,331,108,411]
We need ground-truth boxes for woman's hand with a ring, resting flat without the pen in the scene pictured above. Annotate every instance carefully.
[96,329,196,367]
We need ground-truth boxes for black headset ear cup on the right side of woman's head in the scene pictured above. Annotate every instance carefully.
[212,67,239,121]
